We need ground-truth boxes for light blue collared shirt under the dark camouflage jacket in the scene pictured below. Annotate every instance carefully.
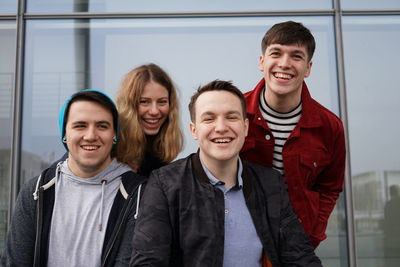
[200,158,263,267]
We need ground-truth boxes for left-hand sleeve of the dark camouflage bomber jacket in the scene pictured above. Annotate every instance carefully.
[130,171,172,267]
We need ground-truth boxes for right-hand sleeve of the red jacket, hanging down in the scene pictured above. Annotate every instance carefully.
[310,123,346,247]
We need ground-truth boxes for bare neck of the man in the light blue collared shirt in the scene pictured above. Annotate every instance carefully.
[200,150,238,188]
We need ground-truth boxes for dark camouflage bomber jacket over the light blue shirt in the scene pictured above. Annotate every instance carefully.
[130,154,321,267]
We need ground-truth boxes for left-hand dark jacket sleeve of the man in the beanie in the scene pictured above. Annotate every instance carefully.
[1,179,36,267]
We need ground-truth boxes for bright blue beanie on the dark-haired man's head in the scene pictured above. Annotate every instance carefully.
[58,89,119,151]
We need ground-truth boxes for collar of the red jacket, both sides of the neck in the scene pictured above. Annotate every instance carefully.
[245,78,322,128]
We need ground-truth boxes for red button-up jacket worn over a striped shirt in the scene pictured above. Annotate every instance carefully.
[241,79,346,247]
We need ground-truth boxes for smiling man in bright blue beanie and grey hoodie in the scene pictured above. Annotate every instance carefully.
[2,90,148,267]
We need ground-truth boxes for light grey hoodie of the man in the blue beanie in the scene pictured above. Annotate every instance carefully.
[48,159,130,267]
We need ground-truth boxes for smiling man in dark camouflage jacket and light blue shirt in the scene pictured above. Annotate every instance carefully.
[130,80,321,267]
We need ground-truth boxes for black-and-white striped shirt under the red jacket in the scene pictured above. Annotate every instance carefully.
[259,89,302,175]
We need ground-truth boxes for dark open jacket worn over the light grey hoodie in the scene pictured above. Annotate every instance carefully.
[1,159,146,267]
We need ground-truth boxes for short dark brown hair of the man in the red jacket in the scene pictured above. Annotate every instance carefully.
[261,21,315,61]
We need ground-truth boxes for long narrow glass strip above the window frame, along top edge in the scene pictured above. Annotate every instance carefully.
[27,0,332,13]
